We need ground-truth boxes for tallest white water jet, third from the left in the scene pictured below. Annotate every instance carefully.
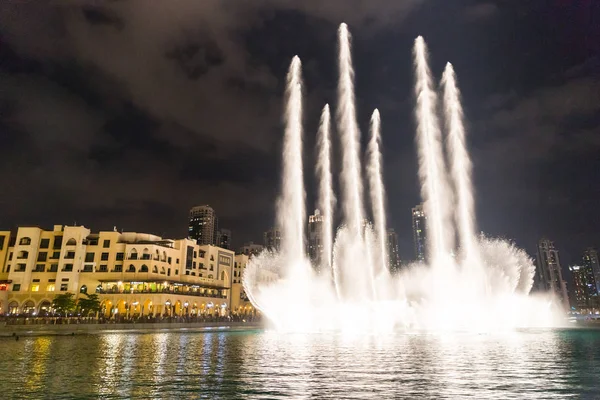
[337,23,364,236]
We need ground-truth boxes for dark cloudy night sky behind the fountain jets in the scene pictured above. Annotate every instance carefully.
[0,0,600,264]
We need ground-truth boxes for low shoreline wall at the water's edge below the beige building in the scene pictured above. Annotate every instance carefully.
[0,321,264,338]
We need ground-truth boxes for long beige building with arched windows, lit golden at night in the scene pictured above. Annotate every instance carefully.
[0,225,258,317]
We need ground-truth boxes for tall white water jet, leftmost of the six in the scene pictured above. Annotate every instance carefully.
[277,56,306,260]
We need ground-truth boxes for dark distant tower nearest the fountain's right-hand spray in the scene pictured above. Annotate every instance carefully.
[534,239,569,307]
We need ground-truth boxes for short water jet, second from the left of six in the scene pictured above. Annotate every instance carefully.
[316,104,339,293]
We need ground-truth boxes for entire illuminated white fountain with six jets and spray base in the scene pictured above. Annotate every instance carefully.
[243,24,560,333]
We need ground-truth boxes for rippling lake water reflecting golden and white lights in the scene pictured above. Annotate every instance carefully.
[0,330,600,399]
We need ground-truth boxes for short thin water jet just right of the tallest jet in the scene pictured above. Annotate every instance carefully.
[367,109,387,271]
